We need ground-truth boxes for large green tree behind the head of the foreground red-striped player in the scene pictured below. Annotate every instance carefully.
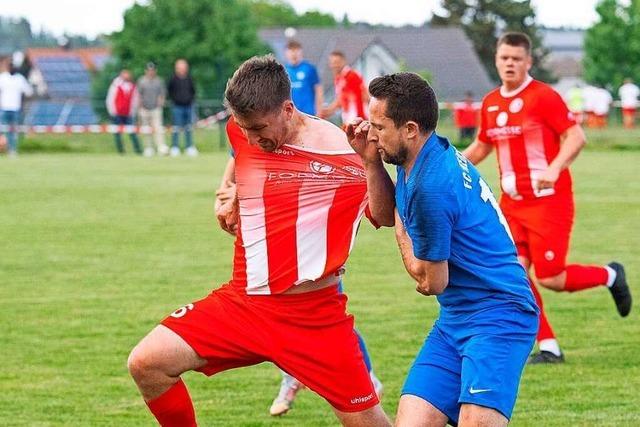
[107,0,268,99]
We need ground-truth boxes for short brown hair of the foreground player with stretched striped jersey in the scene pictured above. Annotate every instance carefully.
[224,55,291,117]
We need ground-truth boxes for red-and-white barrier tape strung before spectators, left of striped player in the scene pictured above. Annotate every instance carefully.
[0,110,229,135]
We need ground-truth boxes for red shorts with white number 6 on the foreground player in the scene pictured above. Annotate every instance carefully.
[162,285,379,412]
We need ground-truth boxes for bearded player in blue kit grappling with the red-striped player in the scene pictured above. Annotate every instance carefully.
[347,73,538,427]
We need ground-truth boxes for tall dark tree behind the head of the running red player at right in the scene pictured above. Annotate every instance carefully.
[431,0,554,82]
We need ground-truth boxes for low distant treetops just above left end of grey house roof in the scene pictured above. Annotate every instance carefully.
[244,0,337,28]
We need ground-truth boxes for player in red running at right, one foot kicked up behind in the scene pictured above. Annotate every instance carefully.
[464,33,631,363]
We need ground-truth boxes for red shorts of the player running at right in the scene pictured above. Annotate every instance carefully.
[500,194,574,279]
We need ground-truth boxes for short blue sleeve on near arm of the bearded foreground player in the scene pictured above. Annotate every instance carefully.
[407,191,459,262]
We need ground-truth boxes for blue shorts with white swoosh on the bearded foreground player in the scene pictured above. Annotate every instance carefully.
[402,305,538,425]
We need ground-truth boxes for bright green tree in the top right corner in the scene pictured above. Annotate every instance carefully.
[583,0,640,89]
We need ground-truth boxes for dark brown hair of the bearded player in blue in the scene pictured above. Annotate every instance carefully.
[369,73,438,132]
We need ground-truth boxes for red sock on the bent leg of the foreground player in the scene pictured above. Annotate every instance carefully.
[147,379,197,427]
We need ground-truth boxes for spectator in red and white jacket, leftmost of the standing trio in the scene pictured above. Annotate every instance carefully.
[106,69,142,154]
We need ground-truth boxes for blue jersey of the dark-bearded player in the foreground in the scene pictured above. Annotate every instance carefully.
[396,132,538,318]
